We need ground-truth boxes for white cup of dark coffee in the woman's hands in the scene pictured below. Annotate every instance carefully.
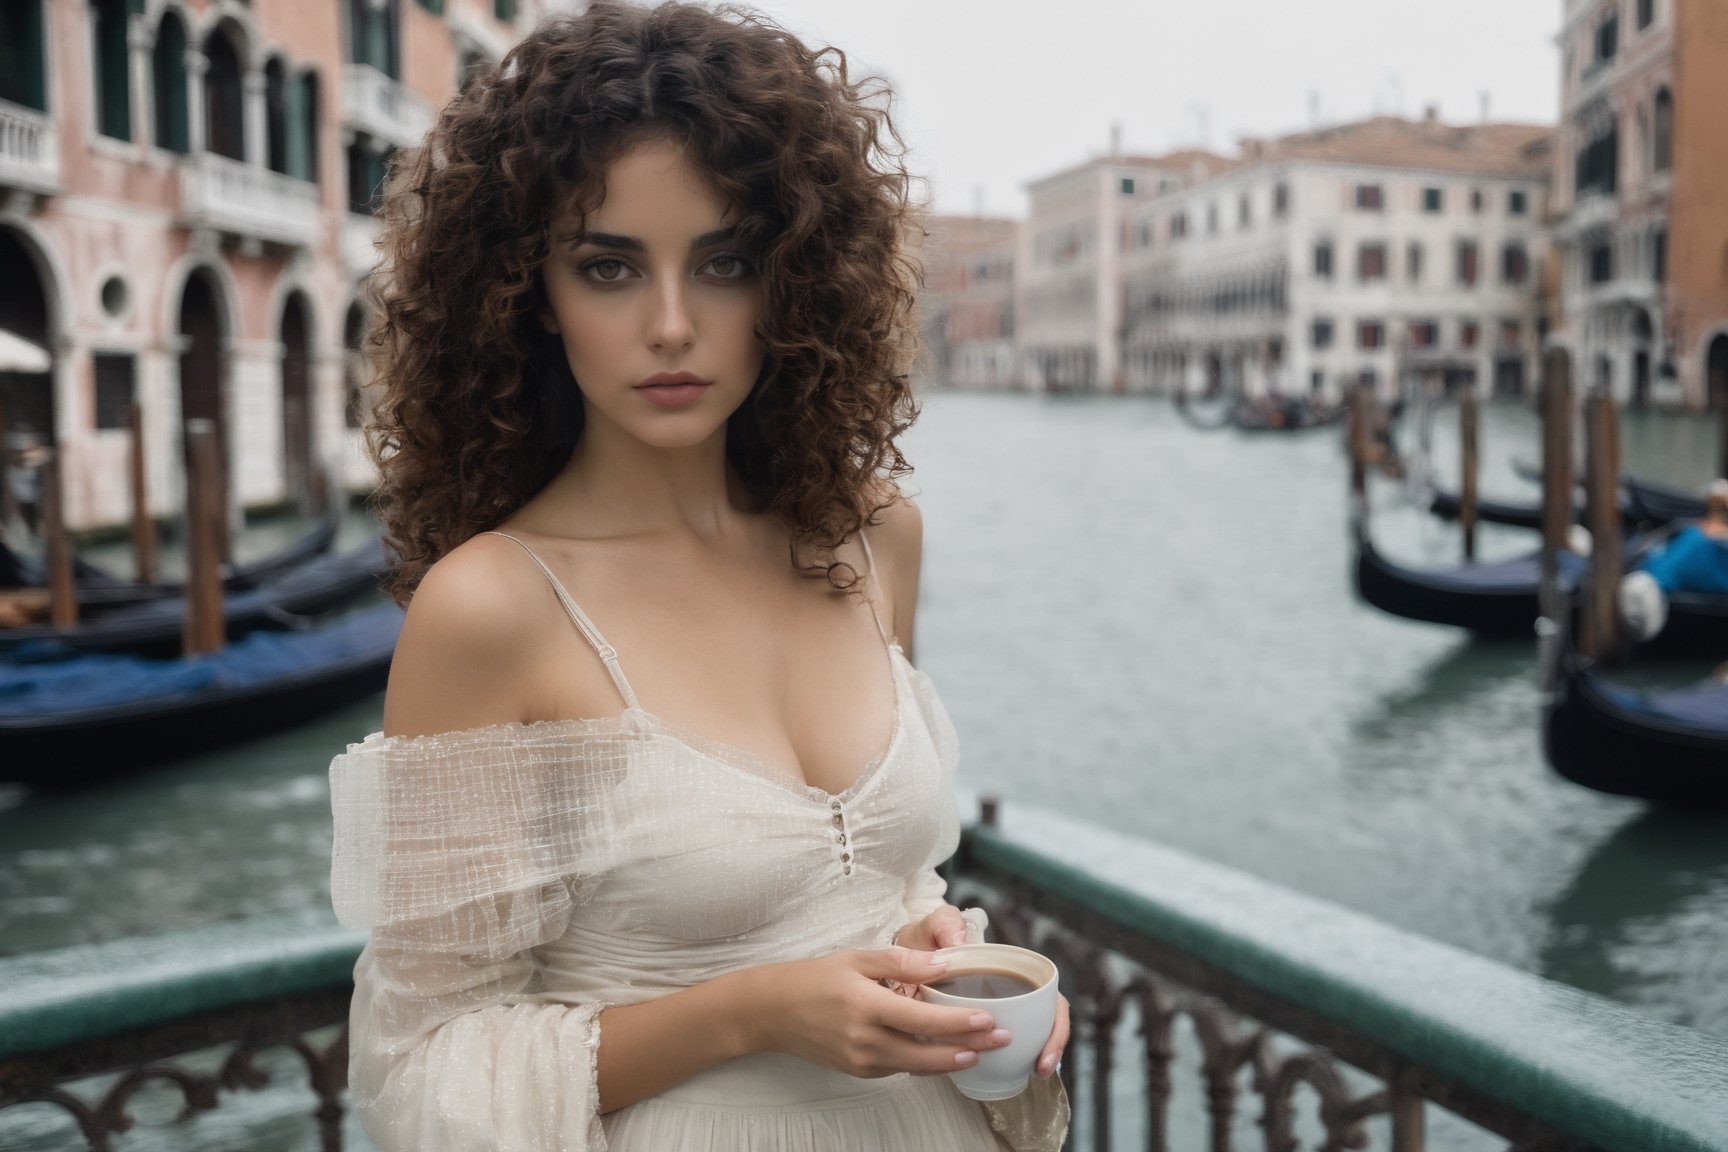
[918,945,1058,1100]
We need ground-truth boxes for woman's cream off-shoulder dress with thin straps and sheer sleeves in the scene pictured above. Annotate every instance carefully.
[330,537,1068,1152]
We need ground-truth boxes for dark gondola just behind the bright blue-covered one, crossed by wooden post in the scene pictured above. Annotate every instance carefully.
[0,539,387,661]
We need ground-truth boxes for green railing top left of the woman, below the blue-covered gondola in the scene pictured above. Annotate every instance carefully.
[0,915,366,1059]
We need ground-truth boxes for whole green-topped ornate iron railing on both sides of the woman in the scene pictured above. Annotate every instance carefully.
[0,803,1728,1152]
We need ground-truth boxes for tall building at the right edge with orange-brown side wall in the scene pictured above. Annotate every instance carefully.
[1553,0,1728,408]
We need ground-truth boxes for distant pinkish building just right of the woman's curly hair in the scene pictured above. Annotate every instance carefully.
[919,216,1020,389]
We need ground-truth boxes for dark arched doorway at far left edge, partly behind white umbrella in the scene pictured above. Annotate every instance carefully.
[0,228,54,532]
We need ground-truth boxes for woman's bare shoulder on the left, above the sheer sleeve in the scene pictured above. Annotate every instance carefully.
[384,535,544,736]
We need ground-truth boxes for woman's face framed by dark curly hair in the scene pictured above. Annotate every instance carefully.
[541,140,764,447]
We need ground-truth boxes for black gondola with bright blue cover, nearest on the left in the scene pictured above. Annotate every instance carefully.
[0,604,403,789]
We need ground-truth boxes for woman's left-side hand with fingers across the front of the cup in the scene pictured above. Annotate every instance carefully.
[738,953,1009,1078]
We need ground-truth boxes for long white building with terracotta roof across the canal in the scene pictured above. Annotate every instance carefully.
[1120,111,1552,397]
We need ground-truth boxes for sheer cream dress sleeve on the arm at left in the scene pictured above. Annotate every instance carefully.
[330,722,627,1152]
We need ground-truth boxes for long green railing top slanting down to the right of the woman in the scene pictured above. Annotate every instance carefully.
[966,805,1728,1152]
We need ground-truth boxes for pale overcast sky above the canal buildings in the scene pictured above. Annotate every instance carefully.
[753,0,1562,216]
